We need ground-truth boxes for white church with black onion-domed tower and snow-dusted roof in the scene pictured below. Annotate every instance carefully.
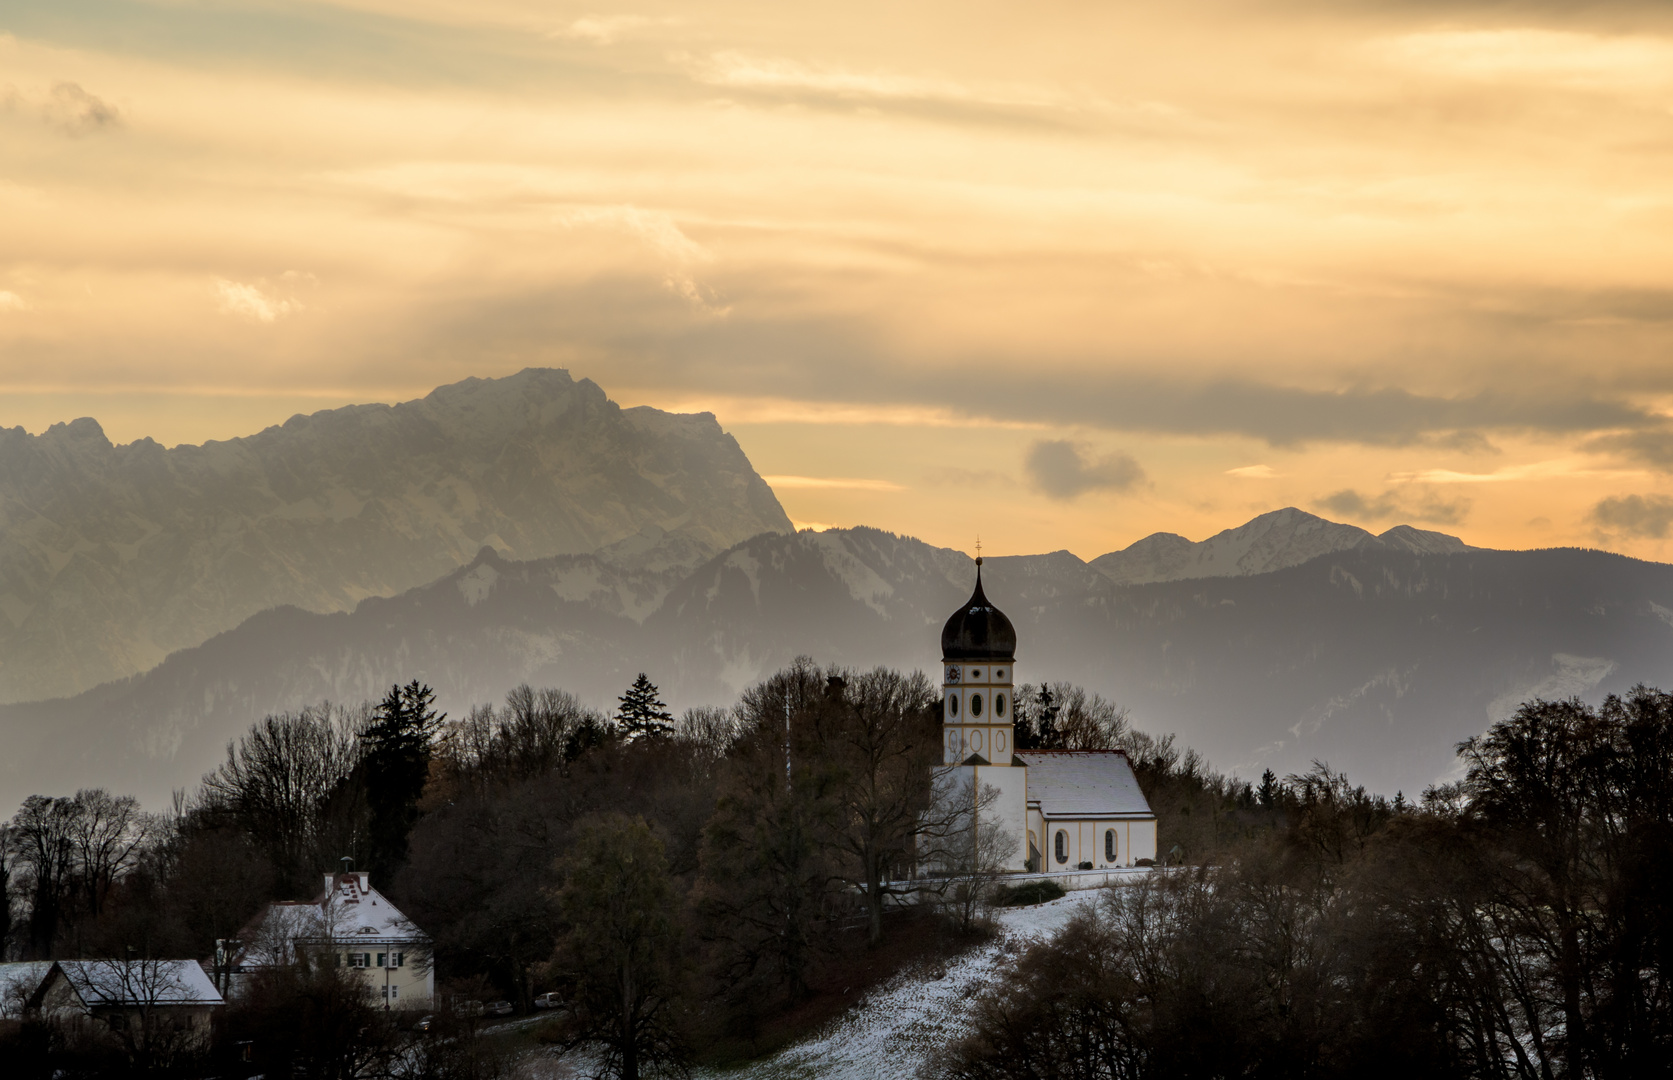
[939,557,1156,873]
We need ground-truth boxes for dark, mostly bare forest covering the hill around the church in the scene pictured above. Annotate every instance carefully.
[0,660,1673,1080]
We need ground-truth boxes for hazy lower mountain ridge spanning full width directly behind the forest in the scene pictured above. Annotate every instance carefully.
[0,512,1673,812]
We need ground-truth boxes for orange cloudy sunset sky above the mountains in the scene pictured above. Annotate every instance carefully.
[0,0,1673,558]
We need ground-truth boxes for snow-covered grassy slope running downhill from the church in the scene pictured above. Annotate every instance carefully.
[693,891,1097,1080]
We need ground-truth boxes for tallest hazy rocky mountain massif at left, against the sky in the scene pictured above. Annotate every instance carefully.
[0,369,791,700]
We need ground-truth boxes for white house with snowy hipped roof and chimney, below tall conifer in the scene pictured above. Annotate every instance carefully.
[233,871,435,1008]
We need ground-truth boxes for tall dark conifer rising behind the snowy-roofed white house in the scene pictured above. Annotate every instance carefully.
[360,679,447,881]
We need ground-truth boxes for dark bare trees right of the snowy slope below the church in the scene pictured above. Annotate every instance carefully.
[939,687,1673,1080]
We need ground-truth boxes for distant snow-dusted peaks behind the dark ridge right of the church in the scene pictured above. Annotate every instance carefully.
[1091,507,1469,585]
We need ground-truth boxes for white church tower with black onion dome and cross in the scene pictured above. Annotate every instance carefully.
[942,557,1017,766]
